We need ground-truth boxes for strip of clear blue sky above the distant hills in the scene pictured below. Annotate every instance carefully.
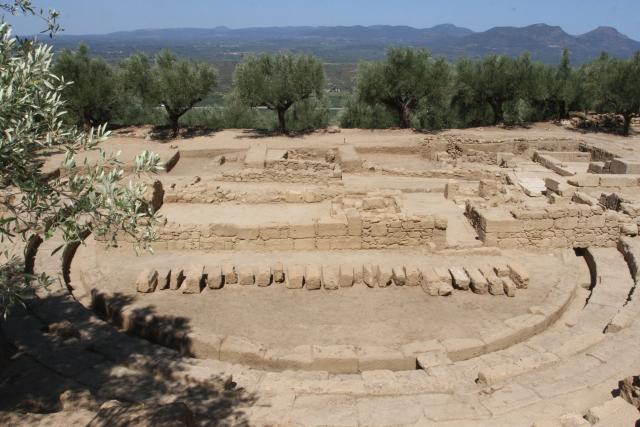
[8,0,640,40]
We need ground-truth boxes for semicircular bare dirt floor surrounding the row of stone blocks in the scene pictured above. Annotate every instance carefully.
[85,244,589,348]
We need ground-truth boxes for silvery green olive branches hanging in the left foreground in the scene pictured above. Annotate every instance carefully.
[0,21,161,313]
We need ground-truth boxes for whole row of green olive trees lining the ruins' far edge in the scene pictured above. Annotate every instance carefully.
[55,45,640,135]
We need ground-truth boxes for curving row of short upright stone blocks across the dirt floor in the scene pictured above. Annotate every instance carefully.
[136,263,529,297]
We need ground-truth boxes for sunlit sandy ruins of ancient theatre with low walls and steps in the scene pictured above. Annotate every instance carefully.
[11,125,640,427]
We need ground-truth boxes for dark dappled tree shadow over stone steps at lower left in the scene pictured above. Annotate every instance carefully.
[0,293,256,426]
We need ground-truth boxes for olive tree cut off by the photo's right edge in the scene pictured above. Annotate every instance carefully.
[585,52,640,136]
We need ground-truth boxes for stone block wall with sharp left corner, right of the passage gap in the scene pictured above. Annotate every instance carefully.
[466,202,633,248]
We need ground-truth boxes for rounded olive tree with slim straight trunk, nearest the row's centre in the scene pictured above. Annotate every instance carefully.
[234,53,325,133]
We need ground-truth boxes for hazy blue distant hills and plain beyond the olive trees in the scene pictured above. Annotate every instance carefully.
[43,24,640,88]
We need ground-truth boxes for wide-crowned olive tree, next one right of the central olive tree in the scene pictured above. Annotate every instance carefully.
[356,47,449,128]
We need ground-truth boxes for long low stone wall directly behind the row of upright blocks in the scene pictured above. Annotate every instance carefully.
[154,211,447,251]
